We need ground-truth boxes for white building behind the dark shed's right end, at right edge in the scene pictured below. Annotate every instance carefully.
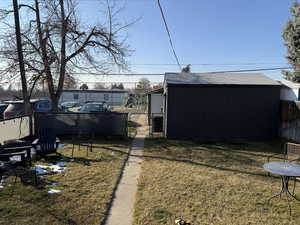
[279,80,300,101]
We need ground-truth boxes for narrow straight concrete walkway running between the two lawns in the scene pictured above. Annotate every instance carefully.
[106,115,147,225]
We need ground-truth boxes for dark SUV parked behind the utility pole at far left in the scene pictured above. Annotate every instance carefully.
[3,99,52,119]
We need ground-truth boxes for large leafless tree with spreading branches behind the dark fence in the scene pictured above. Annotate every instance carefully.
[0,0,131,111]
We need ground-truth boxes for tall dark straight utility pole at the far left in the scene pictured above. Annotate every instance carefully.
[13,0,30,115]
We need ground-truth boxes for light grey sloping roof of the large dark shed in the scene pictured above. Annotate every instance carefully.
[165,73,280,85]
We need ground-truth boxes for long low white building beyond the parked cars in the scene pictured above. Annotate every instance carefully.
[60,89,128,106]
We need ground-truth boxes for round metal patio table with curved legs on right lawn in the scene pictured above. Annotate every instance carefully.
[263,162,300,214]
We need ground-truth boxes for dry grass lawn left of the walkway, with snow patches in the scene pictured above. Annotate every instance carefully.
[0,139,130,225]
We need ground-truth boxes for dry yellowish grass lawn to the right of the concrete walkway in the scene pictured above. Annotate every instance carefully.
[134,138,300,225]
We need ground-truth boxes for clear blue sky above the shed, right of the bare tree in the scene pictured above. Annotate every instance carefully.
[0,0,294,86]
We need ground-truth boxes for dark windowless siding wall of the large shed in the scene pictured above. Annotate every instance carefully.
[166,85,280,141]
